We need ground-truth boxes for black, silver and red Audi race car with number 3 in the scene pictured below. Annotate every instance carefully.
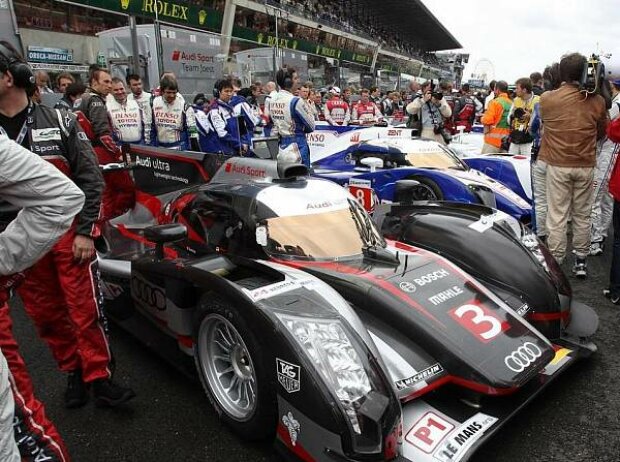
[98,146,595,461]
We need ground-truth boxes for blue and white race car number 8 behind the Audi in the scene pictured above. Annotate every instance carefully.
[313,136,531,223]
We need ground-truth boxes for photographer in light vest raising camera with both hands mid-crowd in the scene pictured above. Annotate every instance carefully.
[407,88,452,145]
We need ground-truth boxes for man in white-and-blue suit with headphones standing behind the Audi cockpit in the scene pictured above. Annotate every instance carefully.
[269,67,314,167]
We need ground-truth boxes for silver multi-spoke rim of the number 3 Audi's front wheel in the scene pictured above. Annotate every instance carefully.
[198,314,256,421]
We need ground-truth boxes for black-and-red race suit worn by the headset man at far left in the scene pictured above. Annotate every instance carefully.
[0,104,104,460]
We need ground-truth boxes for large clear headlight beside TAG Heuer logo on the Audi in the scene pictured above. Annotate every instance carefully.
[276,313,390,454]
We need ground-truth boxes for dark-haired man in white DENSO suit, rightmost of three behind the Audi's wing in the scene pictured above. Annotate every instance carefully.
[151,75,200,151]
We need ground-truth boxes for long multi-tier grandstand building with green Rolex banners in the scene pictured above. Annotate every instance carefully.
[11,0,461,89]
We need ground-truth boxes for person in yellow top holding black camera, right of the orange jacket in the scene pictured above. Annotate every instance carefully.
[507,77,539,157]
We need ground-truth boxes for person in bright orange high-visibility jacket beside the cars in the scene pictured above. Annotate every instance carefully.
[480,80,512,154]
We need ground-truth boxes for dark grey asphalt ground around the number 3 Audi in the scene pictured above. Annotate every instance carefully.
[12,247,620,462]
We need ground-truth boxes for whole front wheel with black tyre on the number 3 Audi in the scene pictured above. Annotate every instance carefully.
[194,293,277,440]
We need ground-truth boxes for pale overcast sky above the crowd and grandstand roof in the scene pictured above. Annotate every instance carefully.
[422,0,620,83]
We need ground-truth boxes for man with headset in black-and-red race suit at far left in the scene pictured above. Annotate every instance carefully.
[0,41,135,416]
